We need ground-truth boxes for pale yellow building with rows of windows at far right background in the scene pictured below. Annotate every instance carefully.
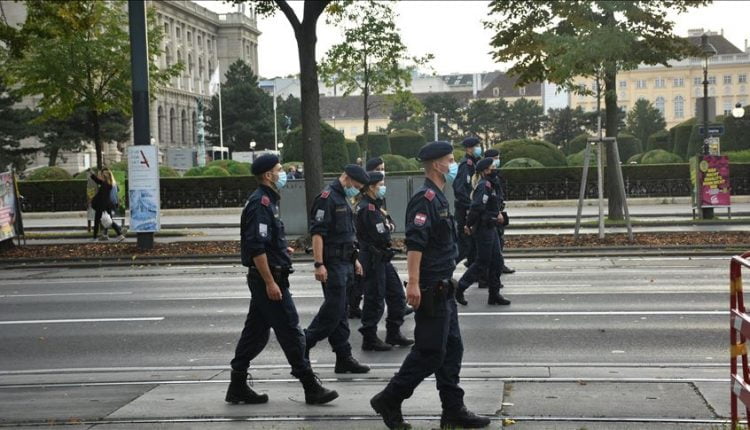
[569,29,750,128]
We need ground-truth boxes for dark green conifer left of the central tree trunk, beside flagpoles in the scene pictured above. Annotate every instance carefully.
[206,60,278,152]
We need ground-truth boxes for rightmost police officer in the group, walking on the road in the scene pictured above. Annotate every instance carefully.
[456,158,510,306]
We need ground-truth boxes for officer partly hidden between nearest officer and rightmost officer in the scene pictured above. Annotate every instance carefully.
[453,137,482,266]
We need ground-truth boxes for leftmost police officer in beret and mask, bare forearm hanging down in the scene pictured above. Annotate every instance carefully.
[226,154,338,404]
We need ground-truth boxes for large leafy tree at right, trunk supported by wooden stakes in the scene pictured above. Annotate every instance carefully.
[485,0,708,219]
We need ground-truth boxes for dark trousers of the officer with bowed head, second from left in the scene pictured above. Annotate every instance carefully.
[305,258,354,356]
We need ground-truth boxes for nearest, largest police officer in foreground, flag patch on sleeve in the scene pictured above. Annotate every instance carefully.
[370,142,490,429]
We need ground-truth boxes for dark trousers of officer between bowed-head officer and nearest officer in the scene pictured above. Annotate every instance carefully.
[359,247,406,335]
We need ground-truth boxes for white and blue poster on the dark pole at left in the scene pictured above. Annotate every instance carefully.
[128,145,160,233]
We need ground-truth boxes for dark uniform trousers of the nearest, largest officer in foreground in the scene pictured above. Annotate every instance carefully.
[385,281,464,411]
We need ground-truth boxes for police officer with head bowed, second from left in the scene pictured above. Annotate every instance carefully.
[305,164,370,373]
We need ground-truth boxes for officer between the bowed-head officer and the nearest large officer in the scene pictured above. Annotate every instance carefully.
[356,171,414,351]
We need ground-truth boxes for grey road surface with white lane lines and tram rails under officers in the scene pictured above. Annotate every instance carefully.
[0,257,740,430]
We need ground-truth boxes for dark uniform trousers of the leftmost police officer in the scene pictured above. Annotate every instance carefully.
[232,272,311,378]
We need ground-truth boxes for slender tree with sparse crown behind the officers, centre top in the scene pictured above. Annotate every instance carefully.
[320,0,432,155]
